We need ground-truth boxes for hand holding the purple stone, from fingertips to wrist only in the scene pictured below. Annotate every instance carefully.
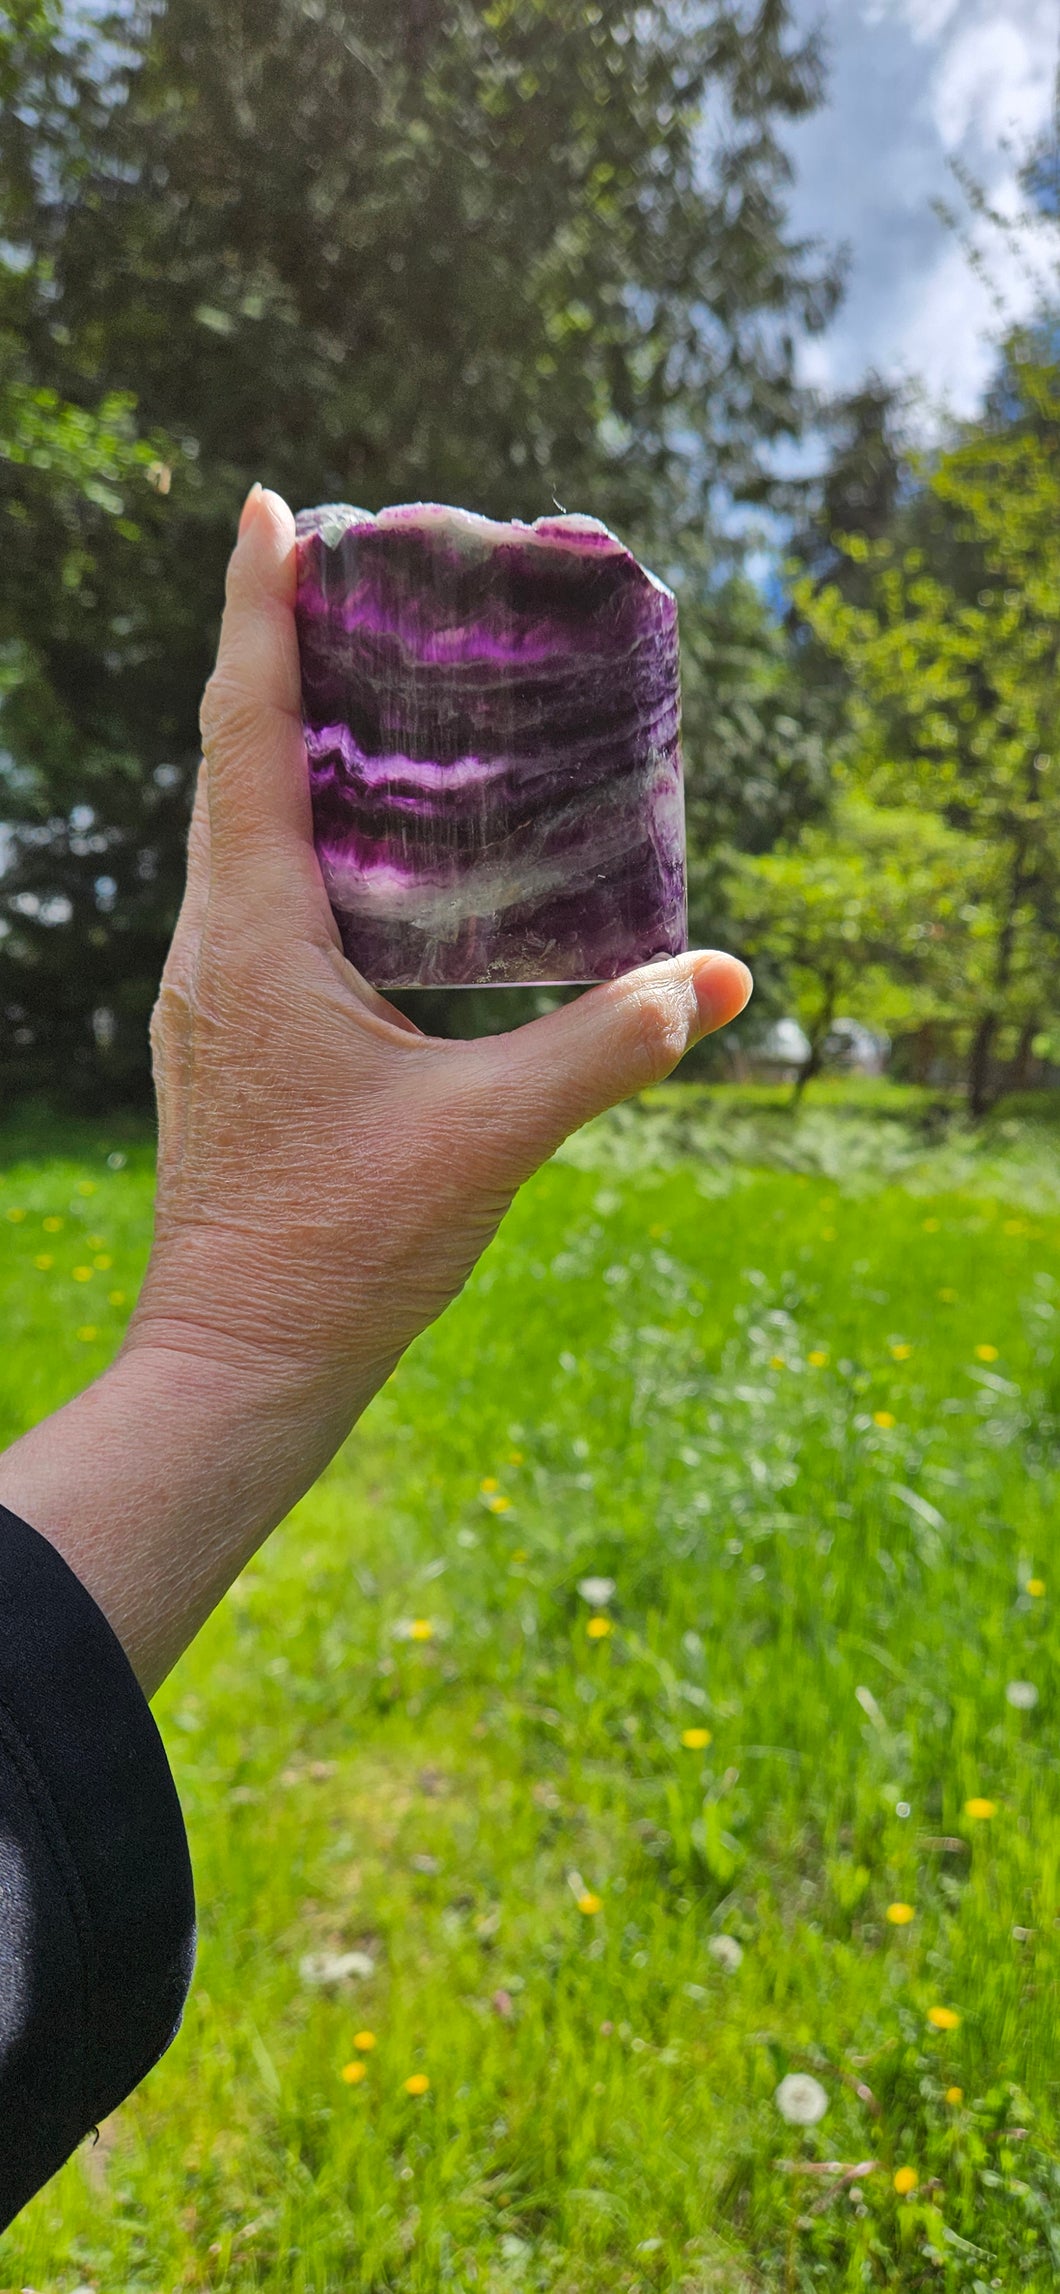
[133,493,750,1415]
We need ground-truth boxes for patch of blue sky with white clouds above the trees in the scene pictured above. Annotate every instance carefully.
[787,0,1060,434]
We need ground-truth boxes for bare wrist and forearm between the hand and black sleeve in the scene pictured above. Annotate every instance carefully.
[0,1344,369,1695]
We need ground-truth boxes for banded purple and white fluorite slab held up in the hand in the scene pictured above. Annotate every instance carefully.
[296,502,686,989]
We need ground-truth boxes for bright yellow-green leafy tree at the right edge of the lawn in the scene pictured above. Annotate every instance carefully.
[794,337,1060,1115]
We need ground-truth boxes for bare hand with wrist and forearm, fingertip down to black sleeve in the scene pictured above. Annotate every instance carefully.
[0,489,750,1686]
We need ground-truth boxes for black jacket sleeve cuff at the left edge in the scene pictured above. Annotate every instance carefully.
[0,1505,195,2230]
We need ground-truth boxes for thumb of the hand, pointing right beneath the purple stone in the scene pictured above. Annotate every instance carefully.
[477,950,753,1170]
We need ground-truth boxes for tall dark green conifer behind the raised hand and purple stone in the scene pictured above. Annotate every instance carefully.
[0,0,837,1087]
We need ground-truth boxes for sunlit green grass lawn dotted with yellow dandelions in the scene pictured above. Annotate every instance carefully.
[0,1094,1060,2294]
